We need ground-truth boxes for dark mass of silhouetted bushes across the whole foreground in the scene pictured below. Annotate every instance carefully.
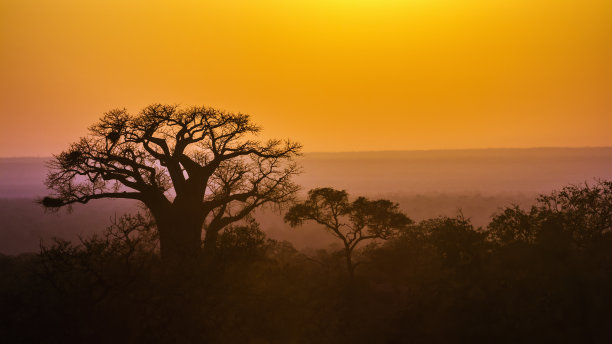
[0,181,612,343]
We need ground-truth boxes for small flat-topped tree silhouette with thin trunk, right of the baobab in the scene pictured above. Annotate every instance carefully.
[285,188,412,279]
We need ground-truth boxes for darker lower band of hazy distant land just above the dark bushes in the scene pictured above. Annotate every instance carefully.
[0,191,537,255]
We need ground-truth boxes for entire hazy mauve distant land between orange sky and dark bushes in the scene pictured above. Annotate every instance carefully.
[0,148,612,254]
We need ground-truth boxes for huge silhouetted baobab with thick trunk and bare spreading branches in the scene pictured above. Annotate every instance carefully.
[41,104,301,265]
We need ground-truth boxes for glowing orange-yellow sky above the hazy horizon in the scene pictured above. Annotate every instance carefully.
[0,0,612,156]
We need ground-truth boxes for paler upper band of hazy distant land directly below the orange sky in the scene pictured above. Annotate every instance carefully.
[0,147,612,198]
